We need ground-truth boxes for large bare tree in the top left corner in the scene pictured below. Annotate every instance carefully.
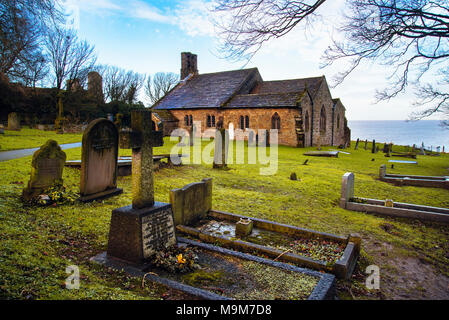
[0,0,64,82]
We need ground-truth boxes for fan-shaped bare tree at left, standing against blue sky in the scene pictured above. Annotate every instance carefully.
[46,26,96,90]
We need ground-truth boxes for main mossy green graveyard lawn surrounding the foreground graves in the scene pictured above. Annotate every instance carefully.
[0,135,449,299]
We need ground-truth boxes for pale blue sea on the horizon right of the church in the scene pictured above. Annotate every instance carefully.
[348,120,449,152]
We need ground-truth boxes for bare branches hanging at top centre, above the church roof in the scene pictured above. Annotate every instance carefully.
[214,0,325,61]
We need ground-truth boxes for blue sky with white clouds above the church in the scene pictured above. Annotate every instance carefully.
[61,0,439,121]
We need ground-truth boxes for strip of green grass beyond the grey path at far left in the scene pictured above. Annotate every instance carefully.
[0,127,83,152]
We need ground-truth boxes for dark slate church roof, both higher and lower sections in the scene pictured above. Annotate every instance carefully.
[153,68,324,112]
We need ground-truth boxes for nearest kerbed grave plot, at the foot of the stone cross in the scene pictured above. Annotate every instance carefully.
[91,237,336,300]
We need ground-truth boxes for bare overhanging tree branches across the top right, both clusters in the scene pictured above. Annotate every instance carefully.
[215,0,449,123]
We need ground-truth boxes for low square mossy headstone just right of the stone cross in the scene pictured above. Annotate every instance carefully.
[170,178,212,225]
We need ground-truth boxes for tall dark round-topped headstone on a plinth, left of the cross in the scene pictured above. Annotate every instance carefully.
[79,119,123,202]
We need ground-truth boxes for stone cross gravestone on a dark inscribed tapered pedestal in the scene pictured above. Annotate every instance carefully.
[107,109,177,263]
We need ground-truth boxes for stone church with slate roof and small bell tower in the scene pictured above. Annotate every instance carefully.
[152,52,350,147]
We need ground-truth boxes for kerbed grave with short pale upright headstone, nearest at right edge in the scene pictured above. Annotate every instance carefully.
[340,172,449,224]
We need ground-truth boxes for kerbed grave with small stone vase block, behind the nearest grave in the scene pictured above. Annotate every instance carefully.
[176,210,361,279]
